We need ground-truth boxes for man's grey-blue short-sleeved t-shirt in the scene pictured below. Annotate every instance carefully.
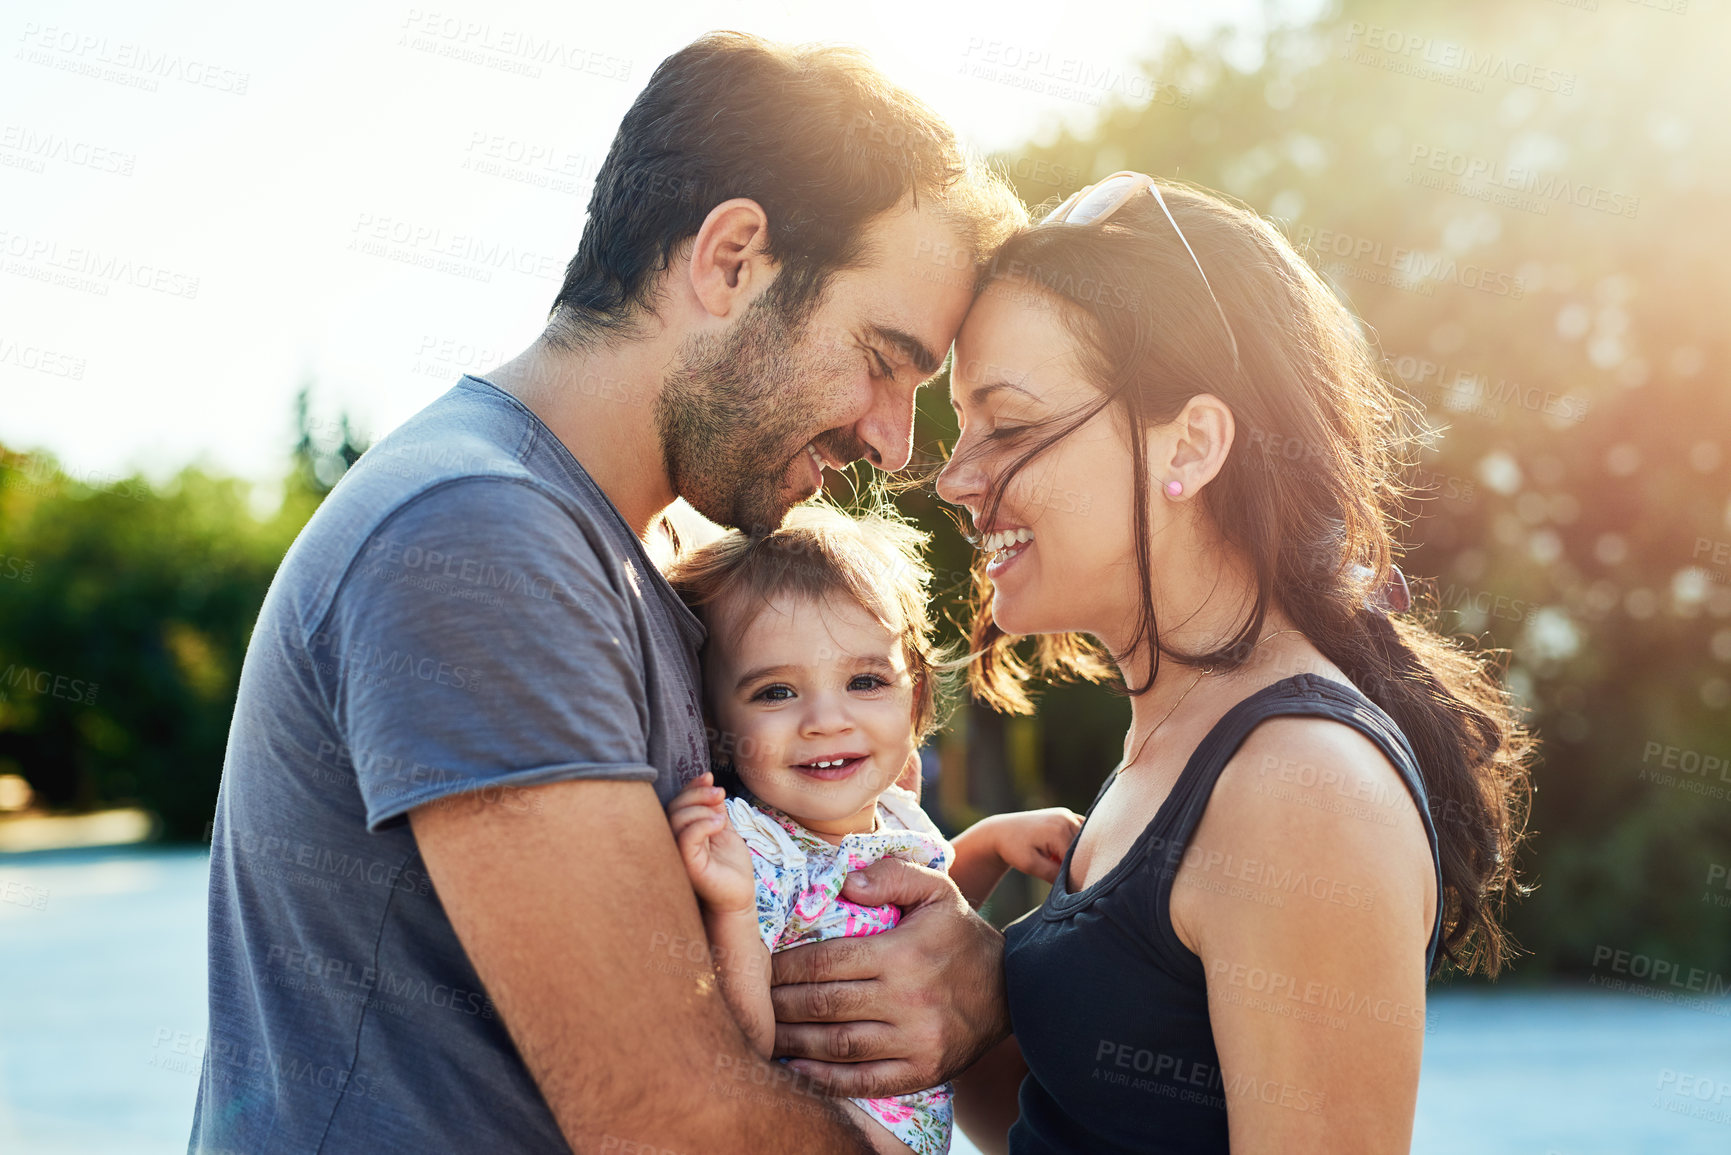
[190,377,710,1155]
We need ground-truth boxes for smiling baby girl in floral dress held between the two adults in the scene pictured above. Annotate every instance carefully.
[668,506,1082,1155]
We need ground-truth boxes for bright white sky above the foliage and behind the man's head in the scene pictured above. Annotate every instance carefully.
[0,0,1314,478]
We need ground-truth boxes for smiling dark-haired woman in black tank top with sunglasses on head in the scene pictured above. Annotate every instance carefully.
[938,173,1528,1155]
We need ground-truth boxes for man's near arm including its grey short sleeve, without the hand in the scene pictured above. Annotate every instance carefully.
[358,476,872,1155]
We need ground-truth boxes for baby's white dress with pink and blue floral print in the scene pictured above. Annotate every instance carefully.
[727,786,956,1155]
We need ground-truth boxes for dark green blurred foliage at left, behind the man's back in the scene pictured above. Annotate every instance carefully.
[0,391,364,840]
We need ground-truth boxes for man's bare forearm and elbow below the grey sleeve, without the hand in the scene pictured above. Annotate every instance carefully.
[410,781,874,1155]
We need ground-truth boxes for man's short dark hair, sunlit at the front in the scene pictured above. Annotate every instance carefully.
[549,33,1026,346]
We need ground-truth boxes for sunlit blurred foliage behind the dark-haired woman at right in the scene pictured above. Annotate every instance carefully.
[904,0,1731,977]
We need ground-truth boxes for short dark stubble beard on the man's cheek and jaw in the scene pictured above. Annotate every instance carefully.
[654,298,824,533]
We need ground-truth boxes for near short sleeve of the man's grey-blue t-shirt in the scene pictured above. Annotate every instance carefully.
[310,478,656,829]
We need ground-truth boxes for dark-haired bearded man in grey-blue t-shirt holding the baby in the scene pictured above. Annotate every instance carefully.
[192,35,1023,1155]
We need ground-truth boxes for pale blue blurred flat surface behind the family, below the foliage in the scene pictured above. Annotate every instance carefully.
[0,850,1731,1155]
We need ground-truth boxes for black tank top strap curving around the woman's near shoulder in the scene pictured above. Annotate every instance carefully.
[1149,674,1442,977]
